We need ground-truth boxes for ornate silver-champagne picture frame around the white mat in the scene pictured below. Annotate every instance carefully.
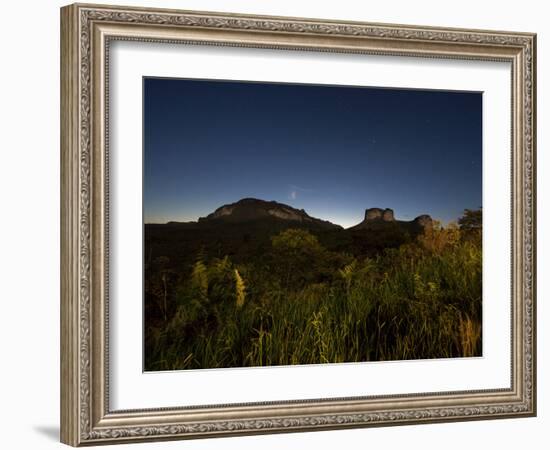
[61,4,536,446]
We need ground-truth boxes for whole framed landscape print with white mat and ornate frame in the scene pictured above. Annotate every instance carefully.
[61,4,536,446]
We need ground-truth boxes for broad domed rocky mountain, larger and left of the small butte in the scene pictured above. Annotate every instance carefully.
[199,198,342,228]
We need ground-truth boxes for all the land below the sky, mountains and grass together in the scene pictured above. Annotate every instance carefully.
[144,199,482,371]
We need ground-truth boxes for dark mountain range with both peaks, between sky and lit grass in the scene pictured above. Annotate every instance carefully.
[149,198,438,268]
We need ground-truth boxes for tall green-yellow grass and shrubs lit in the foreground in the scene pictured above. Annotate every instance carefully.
[145,227,482,370]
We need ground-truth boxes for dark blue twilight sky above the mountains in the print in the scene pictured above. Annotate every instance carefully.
[144,78,482,227]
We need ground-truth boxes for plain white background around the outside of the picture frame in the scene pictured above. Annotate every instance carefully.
[0,0,550,450]
